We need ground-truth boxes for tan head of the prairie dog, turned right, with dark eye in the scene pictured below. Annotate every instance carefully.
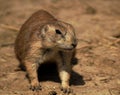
[41,22,77,50]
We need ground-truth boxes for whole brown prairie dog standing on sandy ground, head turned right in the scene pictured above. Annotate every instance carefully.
[15,10,77,93]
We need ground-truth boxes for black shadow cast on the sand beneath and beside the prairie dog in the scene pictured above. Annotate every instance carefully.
[38,63,85,85]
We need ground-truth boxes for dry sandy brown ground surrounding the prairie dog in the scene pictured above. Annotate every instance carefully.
[0,0,120,95]
